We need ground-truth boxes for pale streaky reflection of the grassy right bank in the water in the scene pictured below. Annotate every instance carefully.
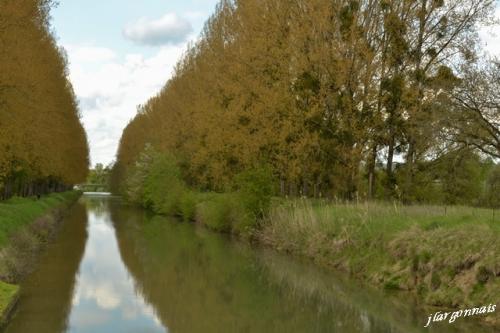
[258,250,492,333]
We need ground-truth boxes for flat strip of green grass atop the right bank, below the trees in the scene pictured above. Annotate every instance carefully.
[263,199,500,248]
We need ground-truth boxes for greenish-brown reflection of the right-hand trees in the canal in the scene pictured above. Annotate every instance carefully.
[113,206,342,332]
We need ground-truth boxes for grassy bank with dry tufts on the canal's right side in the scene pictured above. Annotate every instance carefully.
[259,200,500,322]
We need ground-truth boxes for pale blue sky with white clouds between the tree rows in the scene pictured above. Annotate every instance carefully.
[52,0,500,165]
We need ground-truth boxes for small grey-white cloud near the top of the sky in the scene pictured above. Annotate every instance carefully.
[123,13,193,46]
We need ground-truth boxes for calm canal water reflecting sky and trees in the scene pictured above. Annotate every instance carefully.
[6,194,496,333]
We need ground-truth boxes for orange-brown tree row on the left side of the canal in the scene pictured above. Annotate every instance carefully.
[0,0,89,199]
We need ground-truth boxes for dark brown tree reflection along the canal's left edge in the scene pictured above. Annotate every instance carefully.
[6,203,87,333]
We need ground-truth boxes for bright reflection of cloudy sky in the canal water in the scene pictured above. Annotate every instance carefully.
[65,211,165,332]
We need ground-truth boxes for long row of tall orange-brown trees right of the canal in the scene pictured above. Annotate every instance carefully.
[113,0,500,202]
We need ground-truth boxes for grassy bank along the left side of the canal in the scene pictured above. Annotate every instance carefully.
[0,191,81,326]
